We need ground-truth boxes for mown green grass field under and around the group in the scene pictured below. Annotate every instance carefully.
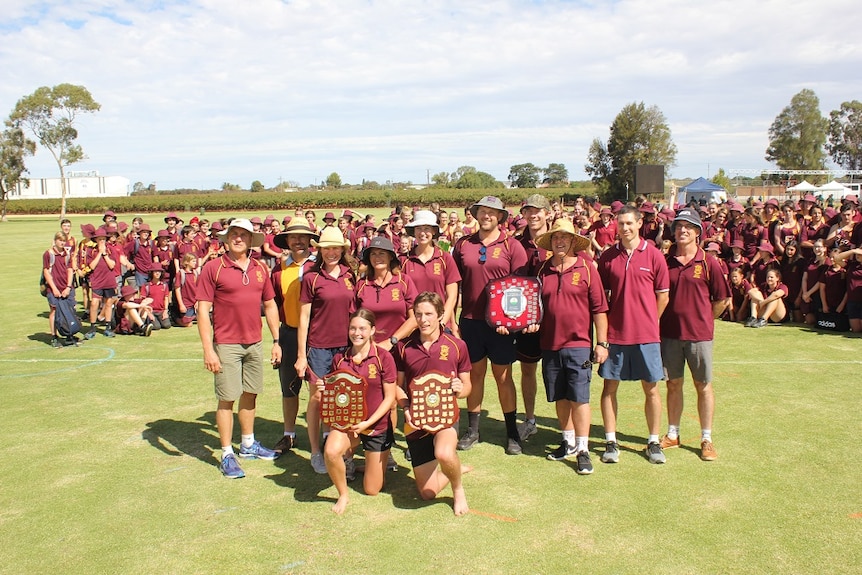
[0,214,862,575]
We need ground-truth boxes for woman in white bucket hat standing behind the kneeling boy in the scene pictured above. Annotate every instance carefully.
[402,210,461,335]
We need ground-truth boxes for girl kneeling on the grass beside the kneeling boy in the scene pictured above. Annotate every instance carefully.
[316,308,398,515]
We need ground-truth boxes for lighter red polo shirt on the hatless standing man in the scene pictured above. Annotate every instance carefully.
[599,238,670,345]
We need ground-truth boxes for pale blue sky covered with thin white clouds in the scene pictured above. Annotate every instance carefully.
[0,0,862,189]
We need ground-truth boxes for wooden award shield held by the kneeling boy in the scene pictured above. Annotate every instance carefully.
[407,371,460,433]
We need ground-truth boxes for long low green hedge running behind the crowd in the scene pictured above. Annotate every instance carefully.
[6,188,600,214]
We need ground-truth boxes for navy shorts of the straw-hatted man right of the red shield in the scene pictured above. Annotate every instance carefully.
[542,347,593,403]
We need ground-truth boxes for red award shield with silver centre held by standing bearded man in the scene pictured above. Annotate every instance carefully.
[485,276,543,331]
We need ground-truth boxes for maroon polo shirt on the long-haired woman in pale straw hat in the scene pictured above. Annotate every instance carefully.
[299,265,356,349]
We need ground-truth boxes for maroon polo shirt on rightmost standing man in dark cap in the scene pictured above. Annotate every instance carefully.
[660,248,730,341]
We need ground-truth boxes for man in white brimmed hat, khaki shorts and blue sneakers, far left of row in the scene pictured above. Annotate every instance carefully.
[197,219,281,479]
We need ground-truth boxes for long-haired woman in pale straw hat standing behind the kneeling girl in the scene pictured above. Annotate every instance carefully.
[294,226,356,474]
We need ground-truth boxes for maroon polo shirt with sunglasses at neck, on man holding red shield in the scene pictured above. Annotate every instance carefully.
[452,231,527,319]
